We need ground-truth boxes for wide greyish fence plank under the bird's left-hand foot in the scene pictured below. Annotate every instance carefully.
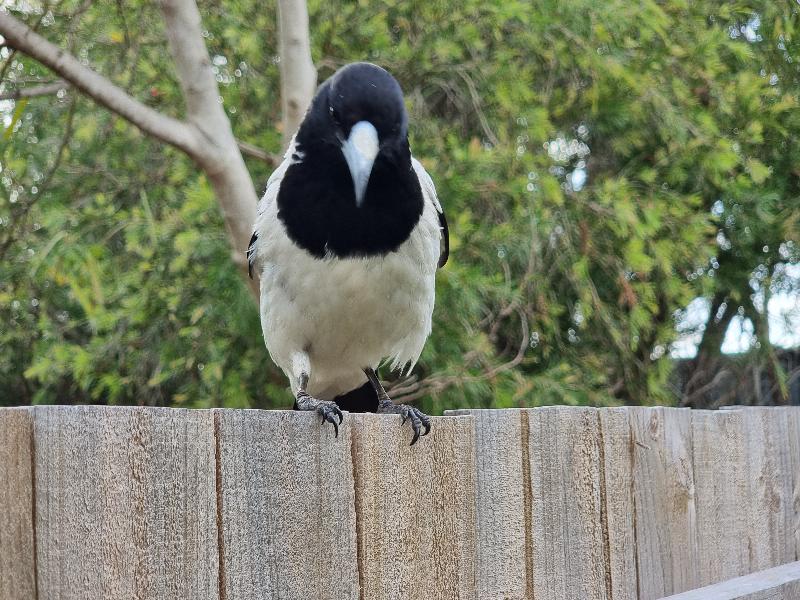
[216,410,360,600]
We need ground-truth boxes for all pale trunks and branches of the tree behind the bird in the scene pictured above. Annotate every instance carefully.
[0,0,316,298]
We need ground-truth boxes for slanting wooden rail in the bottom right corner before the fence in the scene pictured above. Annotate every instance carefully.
[663,562,800,600]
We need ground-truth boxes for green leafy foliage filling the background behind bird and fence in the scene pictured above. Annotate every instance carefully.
[0,0,800,413]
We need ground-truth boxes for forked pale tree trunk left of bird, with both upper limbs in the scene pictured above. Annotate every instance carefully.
[0,0,258,298]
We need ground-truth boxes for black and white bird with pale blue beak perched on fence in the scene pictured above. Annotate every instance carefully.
[247,62,449,446]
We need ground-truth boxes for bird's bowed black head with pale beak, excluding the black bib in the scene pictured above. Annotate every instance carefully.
[309,62,410,206]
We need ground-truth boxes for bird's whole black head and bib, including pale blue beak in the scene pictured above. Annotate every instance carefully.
[278,63,423,257]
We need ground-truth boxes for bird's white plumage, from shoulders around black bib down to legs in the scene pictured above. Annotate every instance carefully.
[254,152,441,399]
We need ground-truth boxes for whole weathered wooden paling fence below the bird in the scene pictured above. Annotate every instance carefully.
[0,407,800,600]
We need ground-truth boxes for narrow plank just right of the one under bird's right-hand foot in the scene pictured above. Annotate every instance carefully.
[446,410,533,600]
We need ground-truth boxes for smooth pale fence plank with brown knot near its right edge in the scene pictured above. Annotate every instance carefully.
[630,407,700,600]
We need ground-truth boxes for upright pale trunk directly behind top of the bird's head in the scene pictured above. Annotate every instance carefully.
[278,0,317,148]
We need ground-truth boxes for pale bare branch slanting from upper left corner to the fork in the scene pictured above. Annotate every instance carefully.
[0,11,202,156]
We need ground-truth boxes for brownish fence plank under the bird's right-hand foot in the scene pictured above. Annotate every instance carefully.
[349,414,476,600]
